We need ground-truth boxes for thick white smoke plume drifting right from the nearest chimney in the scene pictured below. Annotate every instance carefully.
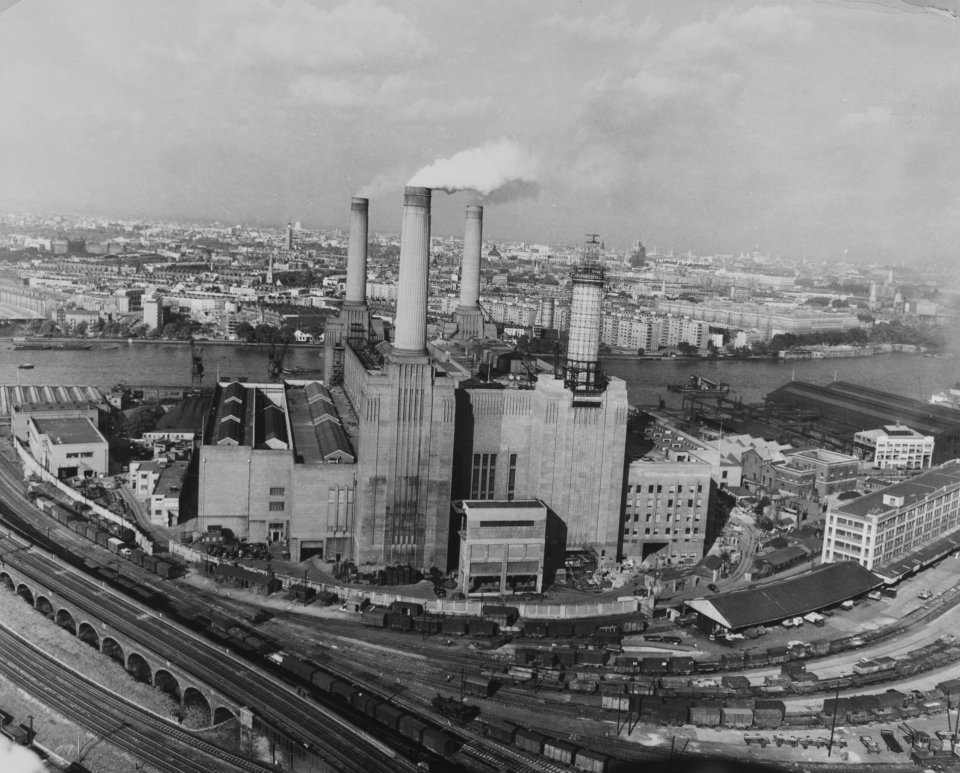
[407,137,538,201]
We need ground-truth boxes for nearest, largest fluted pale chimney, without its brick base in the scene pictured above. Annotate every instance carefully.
[393,185,431,355]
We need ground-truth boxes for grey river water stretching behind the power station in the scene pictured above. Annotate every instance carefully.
[0,341,960,407]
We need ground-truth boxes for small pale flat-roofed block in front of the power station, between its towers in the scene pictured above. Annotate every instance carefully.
[459,499,556,595]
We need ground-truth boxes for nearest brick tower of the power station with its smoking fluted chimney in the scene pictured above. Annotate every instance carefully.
[343,187,456,568]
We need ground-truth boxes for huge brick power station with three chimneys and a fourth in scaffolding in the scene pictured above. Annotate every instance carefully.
[199,187,628,577]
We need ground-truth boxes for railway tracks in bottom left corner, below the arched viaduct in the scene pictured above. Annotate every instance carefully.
[0,624,273,773]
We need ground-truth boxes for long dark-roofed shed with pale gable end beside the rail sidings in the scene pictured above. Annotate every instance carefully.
[687,561,883,630]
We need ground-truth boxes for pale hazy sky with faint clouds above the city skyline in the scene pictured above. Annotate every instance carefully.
[0,0,960,266]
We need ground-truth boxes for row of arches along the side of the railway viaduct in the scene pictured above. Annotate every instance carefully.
[0,565,242,725]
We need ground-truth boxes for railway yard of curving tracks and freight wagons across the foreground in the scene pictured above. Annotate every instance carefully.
[0,432,960,771]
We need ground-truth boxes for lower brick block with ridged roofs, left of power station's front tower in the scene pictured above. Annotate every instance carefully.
[198,382,357,560]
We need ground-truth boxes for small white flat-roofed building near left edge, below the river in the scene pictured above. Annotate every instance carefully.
[27,415,110,478]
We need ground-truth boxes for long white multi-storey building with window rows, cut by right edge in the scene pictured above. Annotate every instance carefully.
[822,460,960,574]
